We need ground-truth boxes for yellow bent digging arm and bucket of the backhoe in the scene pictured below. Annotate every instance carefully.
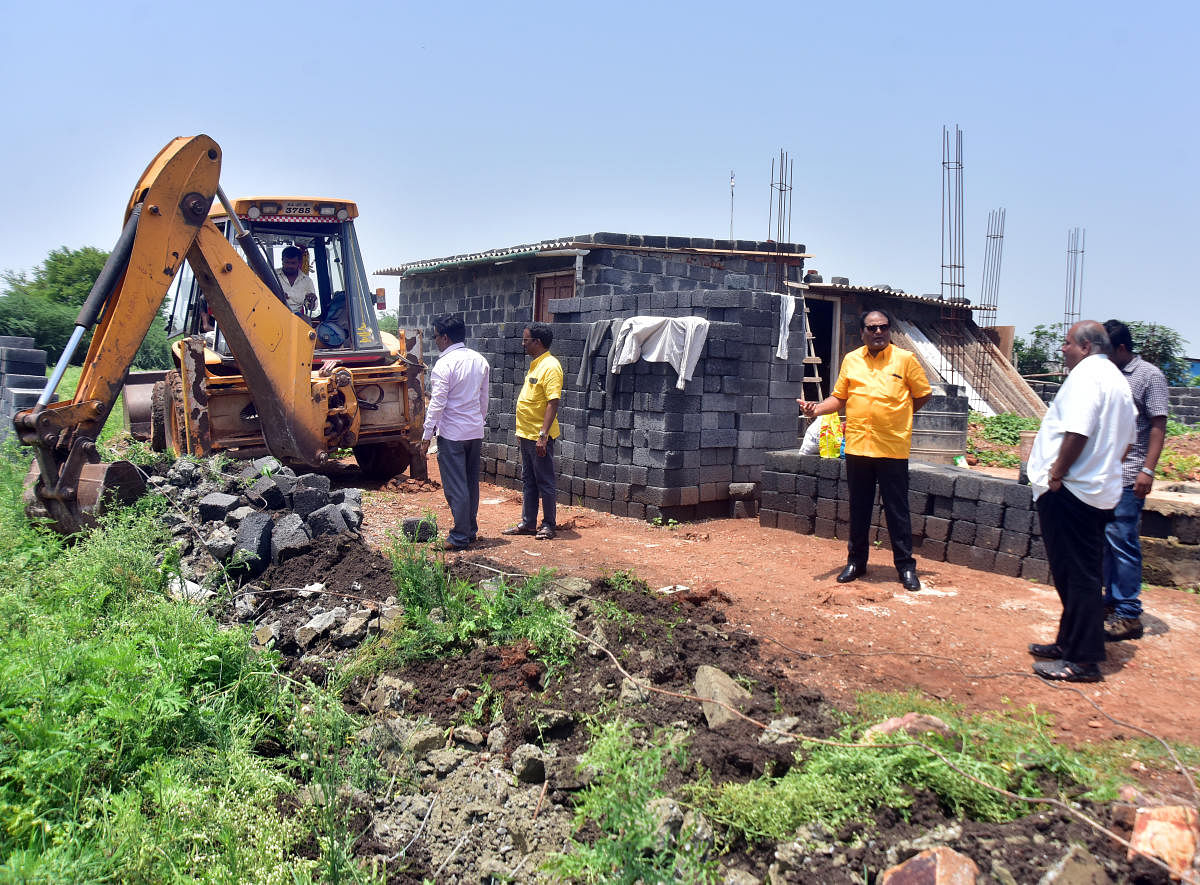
[13,130,353,534]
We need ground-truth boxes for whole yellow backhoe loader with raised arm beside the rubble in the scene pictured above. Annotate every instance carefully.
[13,130,426,534]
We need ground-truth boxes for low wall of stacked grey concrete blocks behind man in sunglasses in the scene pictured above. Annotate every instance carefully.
[758,451,1050,583]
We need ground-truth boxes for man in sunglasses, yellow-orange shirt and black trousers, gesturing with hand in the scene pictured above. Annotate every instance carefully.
[797,309,932,590]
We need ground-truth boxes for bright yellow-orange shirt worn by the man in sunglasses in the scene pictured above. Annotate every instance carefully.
[833,344,932,458]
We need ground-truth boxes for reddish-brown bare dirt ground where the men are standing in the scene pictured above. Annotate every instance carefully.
[348,458,1200,766]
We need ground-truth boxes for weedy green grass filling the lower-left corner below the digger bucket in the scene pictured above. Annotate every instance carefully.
[0,446,379,883]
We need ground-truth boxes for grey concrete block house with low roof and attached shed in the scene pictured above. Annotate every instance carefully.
[377,233,1042,519]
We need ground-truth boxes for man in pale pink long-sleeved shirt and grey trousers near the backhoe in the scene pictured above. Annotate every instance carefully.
[424,314,491,550]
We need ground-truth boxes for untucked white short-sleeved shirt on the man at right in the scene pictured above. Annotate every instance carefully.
[1028,354,1138,510]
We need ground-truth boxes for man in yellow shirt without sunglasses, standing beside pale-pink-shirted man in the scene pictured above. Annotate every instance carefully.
[500,323,563,541]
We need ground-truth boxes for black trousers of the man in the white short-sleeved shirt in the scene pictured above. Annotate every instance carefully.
[1038,487,1112,663]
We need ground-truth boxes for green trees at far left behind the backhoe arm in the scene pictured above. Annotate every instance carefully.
[0,246,170,368]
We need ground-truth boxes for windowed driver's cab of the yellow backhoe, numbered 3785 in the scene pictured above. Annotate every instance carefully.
[167,197,395,365]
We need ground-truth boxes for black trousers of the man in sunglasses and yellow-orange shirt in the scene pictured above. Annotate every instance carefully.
[846,454,917,571]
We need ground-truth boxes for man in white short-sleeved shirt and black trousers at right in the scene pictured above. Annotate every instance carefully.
[1028,320,1136,682]
